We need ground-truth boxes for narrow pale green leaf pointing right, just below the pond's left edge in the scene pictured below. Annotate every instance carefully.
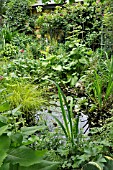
[21,126,47,135]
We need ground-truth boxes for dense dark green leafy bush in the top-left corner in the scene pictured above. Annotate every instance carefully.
[5,0,34,33]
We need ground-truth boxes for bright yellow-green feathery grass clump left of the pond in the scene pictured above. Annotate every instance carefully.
[1,78,47,126]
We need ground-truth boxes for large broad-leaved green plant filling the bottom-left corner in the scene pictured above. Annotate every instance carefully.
[0,93,58,170]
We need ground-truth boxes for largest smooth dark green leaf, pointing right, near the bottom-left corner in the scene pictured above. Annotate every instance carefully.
[5,146,46,167]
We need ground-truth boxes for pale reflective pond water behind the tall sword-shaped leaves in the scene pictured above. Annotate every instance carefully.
[36,96,89,134]
